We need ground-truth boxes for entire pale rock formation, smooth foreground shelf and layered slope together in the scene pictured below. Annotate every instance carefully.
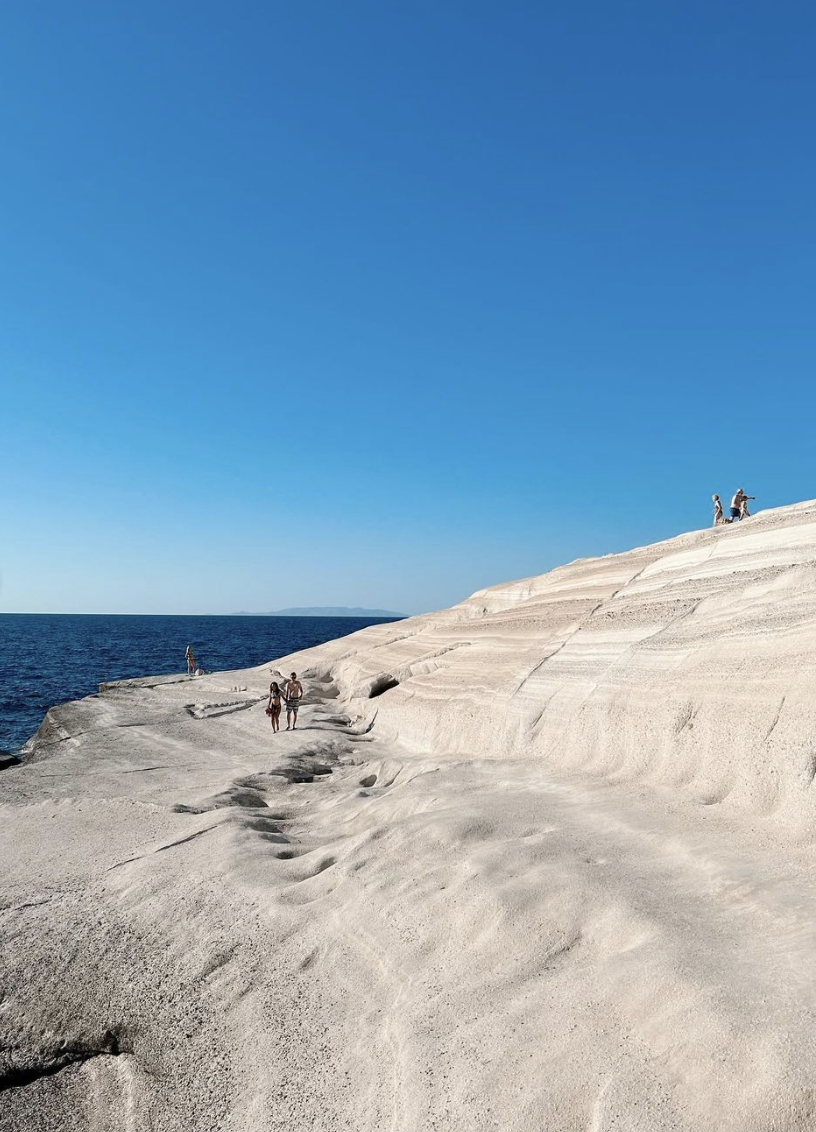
[0,501,816,1132]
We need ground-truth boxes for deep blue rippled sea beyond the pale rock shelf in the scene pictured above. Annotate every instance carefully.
[0,614,398,752]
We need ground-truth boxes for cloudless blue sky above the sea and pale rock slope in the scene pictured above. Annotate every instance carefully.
[0,0,816,612]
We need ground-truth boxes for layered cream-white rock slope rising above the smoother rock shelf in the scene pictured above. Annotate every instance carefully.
[281,503,816,834]
